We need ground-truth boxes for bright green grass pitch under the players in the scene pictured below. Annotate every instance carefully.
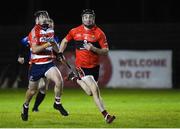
[0,88,180,128]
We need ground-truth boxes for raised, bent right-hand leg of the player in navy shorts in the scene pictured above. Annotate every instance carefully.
[45,67,68,116]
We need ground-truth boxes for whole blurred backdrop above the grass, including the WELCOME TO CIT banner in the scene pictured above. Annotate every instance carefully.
[0,0,180,88]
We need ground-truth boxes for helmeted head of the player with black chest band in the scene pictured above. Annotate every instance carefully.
[81,9,95,28]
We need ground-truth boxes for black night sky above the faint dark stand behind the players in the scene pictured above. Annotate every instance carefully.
[0,0,180,25]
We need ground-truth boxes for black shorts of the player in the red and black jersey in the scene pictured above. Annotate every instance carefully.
[81,65,100,82]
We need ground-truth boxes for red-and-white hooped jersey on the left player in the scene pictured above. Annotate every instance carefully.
[28,25,54,64]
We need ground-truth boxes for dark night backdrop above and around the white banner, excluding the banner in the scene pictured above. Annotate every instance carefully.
[0,0,180,88]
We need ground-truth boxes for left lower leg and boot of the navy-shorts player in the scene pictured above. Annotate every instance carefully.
[21,81,39,121]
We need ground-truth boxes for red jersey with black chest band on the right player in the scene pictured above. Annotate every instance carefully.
[65,25,108,68]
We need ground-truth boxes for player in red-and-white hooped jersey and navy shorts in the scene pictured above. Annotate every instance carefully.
[21,11,68,121]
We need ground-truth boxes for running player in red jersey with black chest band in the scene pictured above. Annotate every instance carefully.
[60,9,115,123]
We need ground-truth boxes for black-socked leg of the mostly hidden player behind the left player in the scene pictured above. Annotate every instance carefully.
[32,78,49,112]
